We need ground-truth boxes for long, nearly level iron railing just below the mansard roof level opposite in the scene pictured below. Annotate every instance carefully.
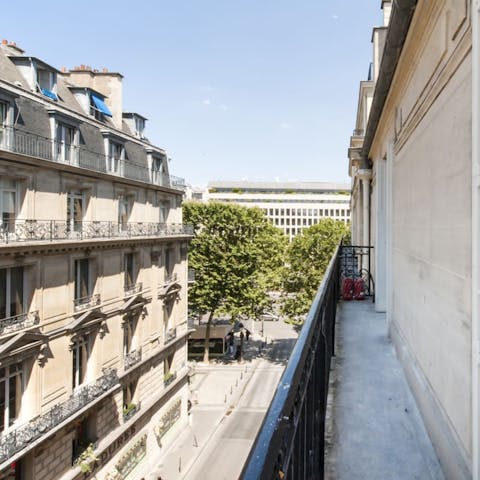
[0,219,193,244]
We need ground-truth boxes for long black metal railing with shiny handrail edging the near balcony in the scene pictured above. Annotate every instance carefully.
[240,247,341,480]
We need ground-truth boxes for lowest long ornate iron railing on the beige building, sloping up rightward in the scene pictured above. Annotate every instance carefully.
[0,369,119,462]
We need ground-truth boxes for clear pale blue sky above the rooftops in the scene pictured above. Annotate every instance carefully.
[0,0,382,186]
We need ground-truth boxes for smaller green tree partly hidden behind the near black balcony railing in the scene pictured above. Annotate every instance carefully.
[282,218,349,323]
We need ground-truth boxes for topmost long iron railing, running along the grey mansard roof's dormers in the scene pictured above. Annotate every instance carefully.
[0,126,185,190]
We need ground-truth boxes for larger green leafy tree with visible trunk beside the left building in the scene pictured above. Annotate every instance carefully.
[183,202,287,362]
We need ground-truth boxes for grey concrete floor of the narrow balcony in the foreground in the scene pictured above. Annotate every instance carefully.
[325,301,444,480]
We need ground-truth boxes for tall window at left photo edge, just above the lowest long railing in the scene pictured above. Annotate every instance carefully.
[0,364,23,432]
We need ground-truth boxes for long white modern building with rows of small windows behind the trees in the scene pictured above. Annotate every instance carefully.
[205,181,350,240]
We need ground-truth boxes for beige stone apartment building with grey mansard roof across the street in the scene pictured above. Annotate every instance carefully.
[0,40,190,480]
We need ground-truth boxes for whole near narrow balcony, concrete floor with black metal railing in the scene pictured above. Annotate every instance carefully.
[240,247,443,480]
